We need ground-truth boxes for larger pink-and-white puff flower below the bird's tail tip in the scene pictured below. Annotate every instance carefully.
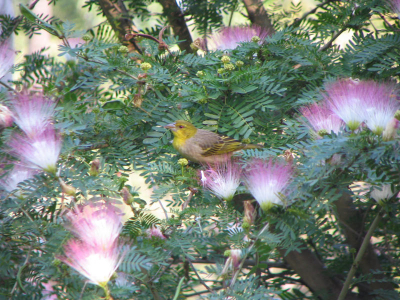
[244,159,293,211]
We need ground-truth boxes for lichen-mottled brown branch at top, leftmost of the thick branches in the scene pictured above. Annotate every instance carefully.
[98,0,141,53]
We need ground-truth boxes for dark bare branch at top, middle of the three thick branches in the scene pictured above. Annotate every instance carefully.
[159,0,193,53]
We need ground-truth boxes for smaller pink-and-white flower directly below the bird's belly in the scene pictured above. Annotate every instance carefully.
[201,159,242,201]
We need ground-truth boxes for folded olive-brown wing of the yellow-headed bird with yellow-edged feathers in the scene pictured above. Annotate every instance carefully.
[196,129,244,156]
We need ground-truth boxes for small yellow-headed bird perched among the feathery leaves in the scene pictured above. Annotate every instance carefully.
[164,120,262,164]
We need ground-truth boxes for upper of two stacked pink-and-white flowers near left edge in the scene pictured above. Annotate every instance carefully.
[13,95,55,138]
